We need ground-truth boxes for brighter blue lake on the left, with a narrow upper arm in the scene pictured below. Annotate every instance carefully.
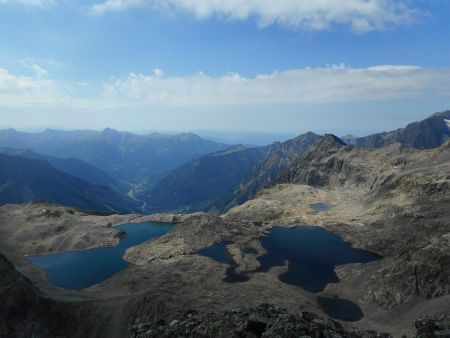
[28,222,173,289]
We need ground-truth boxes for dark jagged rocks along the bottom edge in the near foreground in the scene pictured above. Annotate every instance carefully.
[133,304,450,338]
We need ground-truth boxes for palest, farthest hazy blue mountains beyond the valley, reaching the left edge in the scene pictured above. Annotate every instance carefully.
[0,129,228,185]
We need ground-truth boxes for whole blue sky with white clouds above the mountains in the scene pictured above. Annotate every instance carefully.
[0,0,450,135]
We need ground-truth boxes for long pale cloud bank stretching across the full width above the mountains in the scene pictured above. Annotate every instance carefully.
[0,65,450,110]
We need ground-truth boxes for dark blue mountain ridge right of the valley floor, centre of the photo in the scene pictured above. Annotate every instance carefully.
[141,132,319,211]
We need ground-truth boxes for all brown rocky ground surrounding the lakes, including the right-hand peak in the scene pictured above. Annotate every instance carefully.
[0,121,450,337]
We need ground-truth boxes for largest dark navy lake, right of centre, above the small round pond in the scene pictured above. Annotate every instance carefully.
[256,226,379,293]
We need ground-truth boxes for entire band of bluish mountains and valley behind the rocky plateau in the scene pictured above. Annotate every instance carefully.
[0,111,450,212]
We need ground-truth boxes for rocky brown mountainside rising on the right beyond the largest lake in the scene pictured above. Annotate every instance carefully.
[226,135,450,314]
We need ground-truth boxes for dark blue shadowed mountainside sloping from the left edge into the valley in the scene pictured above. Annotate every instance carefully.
[0,154,137,212]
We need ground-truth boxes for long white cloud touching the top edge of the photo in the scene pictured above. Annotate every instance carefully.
[90,0,419,32]
